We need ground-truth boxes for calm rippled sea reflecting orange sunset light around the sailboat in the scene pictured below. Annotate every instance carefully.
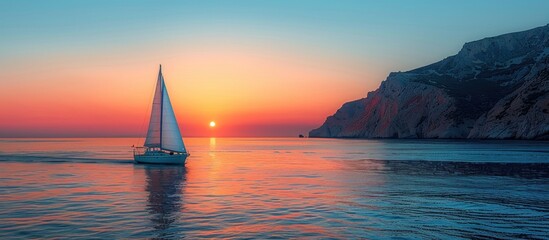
[0,138,549,239]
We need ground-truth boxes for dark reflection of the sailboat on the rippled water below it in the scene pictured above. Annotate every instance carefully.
[144,165,187,238]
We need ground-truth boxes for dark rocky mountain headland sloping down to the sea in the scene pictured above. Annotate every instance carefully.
[309,24,549,139]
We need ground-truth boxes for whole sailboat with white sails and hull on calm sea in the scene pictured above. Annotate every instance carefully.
[133,65,190,164]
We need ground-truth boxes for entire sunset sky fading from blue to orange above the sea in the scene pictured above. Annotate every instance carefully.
[0,0,549,137]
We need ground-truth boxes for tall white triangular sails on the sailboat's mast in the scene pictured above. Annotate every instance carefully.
[145,66,187,152]
